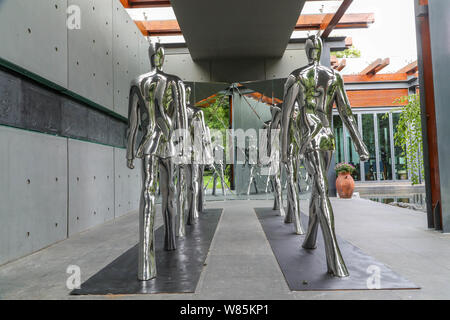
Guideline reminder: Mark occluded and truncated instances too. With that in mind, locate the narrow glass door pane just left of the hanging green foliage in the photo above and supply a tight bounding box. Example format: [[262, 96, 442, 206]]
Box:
[[377, 113, 392, 180]]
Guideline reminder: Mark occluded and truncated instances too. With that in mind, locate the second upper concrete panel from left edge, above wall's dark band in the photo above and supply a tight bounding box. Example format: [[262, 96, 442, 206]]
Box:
[[68, 0, 114, 110]]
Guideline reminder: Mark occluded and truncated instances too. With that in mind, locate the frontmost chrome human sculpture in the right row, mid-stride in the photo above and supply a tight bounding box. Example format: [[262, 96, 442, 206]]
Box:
[[281, 36, 369, 277]]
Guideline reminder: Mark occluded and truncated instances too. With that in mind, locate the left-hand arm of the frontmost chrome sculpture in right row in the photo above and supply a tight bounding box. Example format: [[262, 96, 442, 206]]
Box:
[[280, 75, 299, 163]]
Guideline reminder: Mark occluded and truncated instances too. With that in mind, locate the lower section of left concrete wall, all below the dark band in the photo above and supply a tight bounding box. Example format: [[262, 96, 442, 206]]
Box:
[[0, 126, 141, 264]]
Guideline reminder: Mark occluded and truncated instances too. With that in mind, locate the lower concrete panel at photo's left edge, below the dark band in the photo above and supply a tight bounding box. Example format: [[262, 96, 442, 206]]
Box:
[[0, 127, 67, 264]]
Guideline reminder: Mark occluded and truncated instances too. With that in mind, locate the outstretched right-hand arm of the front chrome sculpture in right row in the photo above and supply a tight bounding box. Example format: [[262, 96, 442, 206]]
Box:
[[335, 72, 369, 161]]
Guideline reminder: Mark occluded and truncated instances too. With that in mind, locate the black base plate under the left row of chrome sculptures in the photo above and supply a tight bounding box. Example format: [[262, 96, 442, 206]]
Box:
[[71, 209, 222, 295]]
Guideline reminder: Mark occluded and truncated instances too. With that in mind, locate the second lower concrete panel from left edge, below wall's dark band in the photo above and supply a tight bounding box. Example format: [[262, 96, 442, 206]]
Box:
[[69, 139, 114, 236]]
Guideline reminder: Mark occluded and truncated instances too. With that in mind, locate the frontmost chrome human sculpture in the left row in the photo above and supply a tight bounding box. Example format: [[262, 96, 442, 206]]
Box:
[[127, 43, 187, 280]]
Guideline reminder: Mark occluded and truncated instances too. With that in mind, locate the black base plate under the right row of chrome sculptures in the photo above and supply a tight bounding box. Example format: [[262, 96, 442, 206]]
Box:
[[255, 208, 419, 291]]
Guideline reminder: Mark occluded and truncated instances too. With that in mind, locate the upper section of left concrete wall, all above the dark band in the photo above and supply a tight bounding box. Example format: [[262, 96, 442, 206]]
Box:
[[0, 0, 148, 117]]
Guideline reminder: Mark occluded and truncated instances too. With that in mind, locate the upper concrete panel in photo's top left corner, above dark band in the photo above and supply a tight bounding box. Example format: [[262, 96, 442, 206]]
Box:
[[0, 0, 67, 87]]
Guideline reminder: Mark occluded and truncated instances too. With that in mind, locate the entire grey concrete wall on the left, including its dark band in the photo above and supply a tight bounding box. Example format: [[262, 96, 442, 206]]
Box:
[[0, 0, 145, 264]]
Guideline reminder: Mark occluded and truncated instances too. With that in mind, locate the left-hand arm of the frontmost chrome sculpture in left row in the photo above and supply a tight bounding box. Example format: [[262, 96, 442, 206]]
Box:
[[127, 87, 140, 169]]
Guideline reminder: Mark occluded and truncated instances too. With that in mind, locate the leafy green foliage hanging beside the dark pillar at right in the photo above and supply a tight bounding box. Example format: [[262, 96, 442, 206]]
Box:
[[385, 94, 423, 184]]
